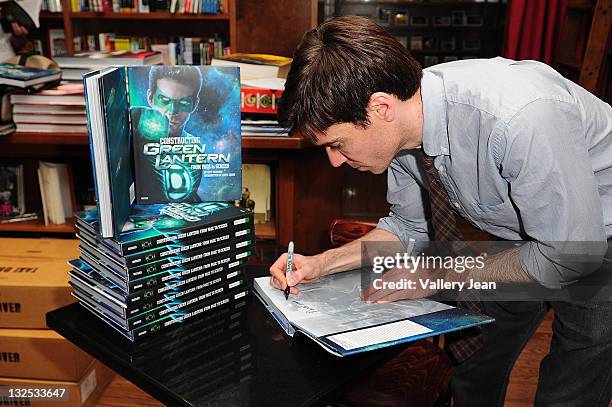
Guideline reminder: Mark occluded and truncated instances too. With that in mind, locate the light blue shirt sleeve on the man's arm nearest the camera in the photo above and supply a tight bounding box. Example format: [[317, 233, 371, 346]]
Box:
[[502, 100, 607, 288]]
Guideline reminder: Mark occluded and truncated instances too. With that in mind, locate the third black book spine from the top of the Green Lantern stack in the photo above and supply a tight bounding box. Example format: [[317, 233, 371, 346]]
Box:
[[124, 237, 255, 279]]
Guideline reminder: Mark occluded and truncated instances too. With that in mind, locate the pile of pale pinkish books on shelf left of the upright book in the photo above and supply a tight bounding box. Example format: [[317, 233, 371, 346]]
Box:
[[11, 84, 87, 133]]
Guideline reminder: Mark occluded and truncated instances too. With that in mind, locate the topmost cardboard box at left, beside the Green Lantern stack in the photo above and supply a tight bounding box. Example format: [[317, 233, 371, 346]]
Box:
[[0, 238, 79, 328]]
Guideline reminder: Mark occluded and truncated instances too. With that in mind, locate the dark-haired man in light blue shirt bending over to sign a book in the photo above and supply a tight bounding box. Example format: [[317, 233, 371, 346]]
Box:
[[270, 17, 612, 407]]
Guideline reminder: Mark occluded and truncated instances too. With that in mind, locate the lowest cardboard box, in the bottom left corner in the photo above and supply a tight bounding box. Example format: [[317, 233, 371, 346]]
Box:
[[0, 360, 115, 407]]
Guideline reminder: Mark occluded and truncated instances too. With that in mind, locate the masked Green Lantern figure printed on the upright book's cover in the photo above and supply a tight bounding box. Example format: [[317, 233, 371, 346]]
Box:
[[130, 66, 202, 203]]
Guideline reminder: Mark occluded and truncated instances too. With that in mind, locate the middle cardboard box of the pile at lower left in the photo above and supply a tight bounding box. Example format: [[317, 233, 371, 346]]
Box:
[[0, 329, 93, 382]]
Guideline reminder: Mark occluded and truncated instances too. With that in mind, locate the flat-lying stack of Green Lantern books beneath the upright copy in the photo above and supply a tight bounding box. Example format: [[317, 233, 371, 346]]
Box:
[[70, 202, 255, 341]]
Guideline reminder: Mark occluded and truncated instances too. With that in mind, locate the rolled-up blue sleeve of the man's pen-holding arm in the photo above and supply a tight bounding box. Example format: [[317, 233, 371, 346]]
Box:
[[377, 151, 429, 247]]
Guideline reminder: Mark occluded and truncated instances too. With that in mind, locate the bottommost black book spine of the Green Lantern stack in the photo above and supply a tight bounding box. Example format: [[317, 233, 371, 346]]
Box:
[[132, 288, 249, 340]]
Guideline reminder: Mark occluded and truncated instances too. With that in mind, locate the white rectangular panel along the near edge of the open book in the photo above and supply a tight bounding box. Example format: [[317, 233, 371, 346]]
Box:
[[327, 321, 431, 350]]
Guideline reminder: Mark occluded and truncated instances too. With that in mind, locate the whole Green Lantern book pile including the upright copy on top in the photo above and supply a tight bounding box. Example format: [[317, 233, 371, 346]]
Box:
[[75, 66, 247, 341]]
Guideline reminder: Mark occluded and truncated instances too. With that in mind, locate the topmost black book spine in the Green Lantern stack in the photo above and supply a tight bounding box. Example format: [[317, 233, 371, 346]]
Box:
[[120, 212, 254, 256]]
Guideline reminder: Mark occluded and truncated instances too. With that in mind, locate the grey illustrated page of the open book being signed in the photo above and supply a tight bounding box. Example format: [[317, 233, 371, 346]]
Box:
[[255, 270, 453, 337]]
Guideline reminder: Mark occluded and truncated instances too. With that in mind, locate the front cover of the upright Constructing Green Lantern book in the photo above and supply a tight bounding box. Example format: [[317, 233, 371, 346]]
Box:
[[128, 66, 242, 204]]
